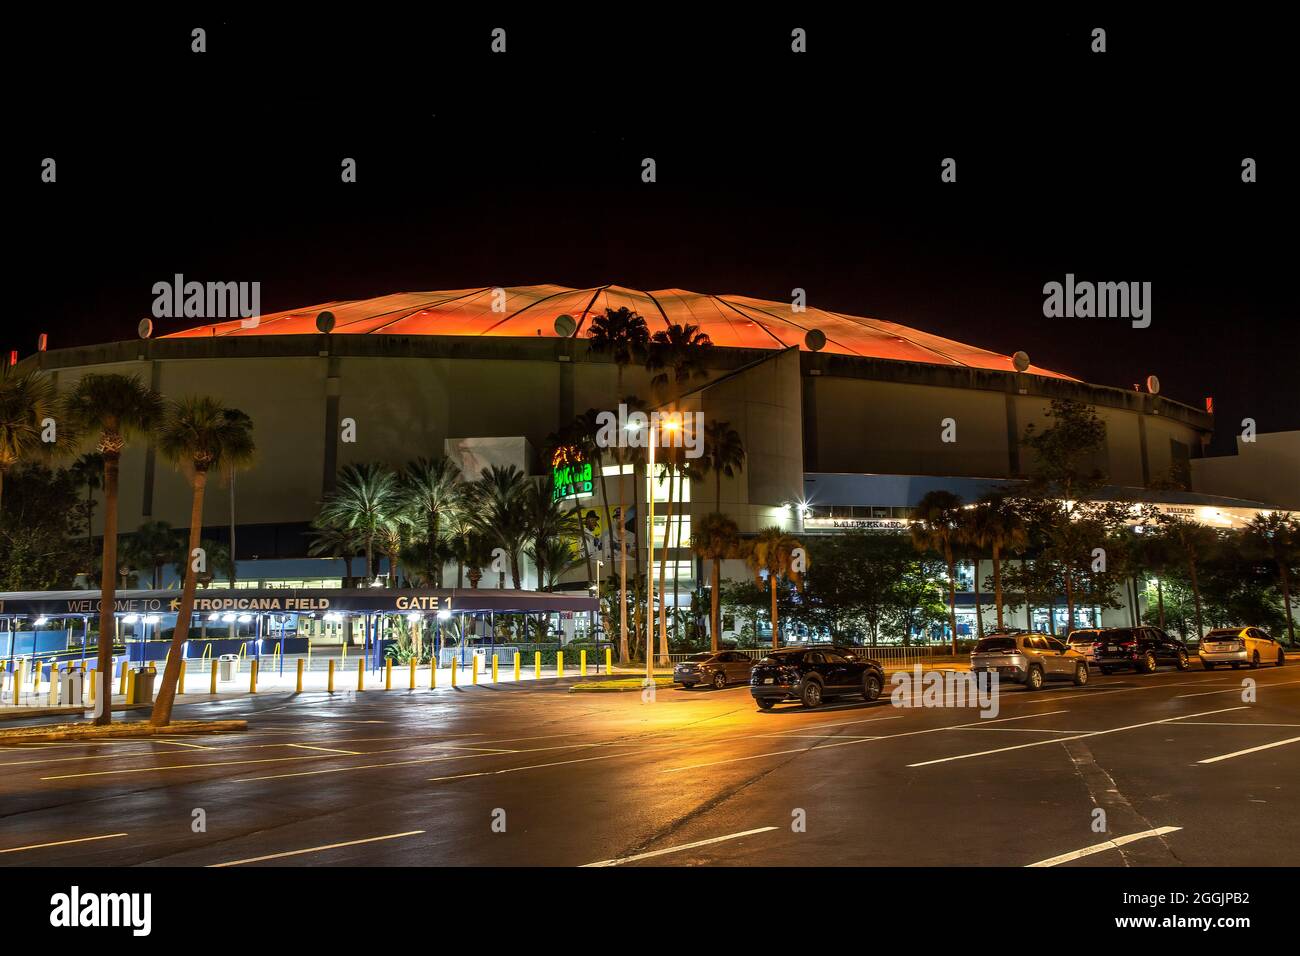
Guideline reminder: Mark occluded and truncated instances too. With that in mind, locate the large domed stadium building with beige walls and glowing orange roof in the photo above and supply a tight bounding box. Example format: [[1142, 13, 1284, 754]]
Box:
[[22, 285, 1266, 639]]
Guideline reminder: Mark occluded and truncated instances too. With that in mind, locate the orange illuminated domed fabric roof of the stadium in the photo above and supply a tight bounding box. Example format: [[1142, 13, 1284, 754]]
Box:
[[164, 285, 1073, 380]]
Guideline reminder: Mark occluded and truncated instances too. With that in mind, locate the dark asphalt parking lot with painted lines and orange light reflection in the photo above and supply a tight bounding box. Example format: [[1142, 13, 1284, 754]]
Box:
[[0, 666, 1300, 866]]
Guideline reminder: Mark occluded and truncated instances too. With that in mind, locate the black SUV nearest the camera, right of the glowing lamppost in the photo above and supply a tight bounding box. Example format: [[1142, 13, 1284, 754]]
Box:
[[749, 644, 885, 710]]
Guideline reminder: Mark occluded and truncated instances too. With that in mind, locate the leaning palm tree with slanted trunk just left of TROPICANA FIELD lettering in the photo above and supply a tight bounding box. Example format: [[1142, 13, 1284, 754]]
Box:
[[150, 395, 255, 727]]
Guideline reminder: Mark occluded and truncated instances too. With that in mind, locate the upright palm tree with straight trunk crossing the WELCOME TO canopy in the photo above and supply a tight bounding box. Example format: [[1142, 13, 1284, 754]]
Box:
[[64, 373, 163, 724]]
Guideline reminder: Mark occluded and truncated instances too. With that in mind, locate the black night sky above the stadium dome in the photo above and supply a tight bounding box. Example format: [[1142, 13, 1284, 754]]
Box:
[[0, 8, 1300, 453]]
